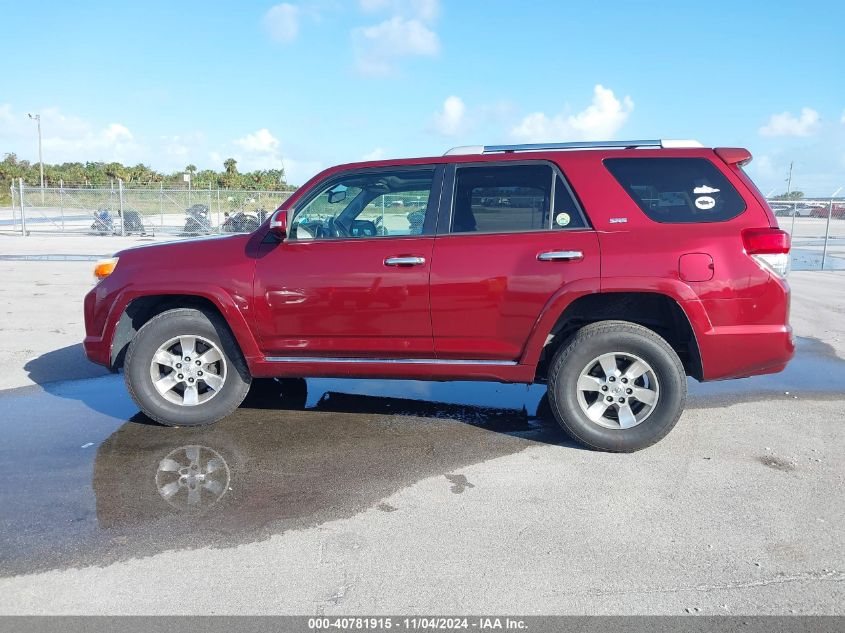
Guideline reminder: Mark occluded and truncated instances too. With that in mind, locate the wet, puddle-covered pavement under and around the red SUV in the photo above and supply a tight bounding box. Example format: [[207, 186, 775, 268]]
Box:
[[0, 339, 845, 577]]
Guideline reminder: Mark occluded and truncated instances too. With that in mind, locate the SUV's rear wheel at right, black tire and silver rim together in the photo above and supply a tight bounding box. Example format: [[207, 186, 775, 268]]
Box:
[[549, 321, 686, 452]]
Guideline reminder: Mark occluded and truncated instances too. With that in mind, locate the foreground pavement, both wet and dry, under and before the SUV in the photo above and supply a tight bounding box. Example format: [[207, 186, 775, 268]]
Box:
[[0, 339, 845, 614]]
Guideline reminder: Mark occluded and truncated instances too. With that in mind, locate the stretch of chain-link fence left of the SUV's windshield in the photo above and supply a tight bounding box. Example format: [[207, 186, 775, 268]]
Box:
[[0, 181, 291, 237]]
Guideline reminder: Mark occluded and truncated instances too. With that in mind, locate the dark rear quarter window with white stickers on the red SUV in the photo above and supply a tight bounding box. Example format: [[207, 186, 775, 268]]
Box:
[[604, 158, 745, 223]]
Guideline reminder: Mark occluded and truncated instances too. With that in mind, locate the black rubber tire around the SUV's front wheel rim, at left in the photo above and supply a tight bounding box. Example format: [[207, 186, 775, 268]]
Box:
[[124, 308, 252, 426]]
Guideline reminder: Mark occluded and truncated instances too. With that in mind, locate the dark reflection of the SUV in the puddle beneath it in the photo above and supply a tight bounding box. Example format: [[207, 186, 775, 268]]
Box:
[[93, 380, 566, 553]]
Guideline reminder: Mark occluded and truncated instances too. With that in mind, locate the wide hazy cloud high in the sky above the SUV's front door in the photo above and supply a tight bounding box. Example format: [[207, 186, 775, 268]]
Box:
[[352, 15, 440, 75]]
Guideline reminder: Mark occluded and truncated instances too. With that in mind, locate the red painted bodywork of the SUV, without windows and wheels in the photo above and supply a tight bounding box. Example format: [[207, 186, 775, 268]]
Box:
[[85, 148, 794, 382]]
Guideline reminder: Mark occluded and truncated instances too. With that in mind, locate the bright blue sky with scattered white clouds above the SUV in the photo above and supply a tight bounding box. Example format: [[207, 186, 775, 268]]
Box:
[[0, 0, 845, 196]]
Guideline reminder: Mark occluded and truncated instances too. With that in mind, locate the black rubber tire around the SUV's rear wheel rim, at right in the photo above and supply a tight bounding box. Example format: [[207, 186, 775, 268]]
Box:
[[548, 321, 687, 453]]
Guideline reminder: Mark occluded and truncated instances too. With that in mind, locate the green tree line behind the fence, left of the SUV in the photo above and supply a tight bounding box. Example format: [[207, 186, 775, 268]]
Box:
[[0, 154, 296, 201]]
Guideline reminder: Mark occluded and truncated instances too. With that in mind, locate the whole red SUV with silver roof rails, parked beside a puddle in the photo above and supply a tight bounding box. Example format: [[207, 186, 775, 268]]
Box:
[[85, 141, 794, 451]]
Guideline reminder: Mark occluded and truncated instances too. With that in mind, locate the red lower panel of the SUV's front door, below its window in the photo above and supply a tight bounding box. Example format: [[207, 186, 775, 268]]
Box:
[[254, 237, 434, 358]]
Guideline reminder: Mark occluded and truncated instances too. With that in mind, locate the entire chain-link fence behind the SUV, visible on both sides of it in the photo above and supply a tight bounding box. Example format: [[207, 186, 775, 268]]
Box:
[[0, 181, 845, 270]]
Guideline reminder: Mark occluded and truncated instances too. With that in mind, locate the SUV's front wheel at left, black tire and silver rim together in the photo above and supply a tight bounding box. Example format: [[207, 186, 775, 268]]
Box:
[[124, 308, 251, 426]]
